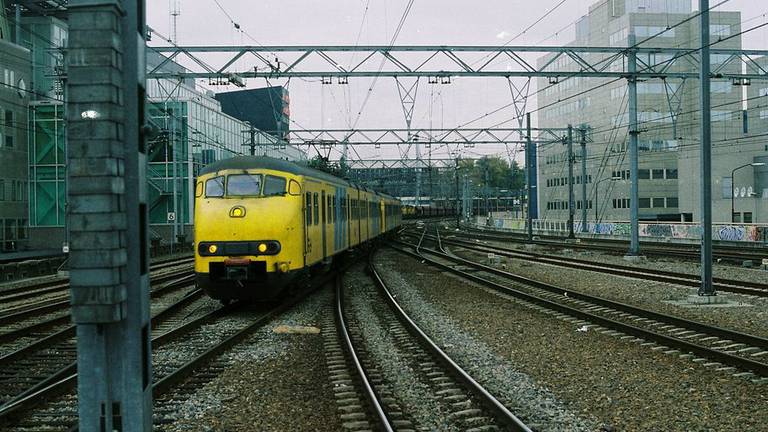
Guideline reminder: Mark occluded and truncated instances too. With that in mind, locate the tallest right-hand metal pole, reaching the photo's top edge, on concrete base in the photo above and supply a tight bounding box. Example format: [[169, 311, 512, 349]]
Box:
[[699, 0, 717, 296]]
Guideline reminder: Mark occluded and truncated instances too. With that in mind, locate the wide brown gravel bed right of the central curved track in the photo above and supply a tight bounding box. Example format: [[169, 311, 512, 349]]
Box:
[[378, 246, 768, 431]]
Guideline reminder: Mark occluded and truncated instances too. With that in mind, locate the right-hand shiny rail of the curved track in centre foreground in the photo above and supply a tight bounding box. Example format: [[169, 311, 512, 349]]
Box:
[[368, 253, 531, 432]]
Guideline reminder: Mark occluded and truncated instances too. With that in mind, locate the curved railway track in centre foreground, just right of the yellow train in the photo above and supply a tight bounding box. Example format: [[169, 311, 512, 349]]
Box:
[[334, 255, 531, 431]]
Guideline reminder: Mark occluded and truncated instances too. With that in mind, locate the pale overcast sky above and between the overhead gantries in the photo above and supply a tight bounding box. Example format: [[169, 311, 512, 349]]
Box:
[[147, 0, 768, 162]]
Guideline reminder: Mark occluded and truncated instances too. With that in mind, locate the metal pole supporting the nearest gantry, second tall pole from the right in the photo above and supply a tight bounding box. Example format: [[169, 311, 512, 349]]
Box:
[[628, 33, 640, 256]]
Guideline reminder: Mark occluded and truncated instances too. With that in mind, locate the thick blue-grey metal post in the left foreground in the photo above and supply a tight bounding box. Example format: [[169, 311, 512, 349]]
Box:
[[66, 0, 152, 432]]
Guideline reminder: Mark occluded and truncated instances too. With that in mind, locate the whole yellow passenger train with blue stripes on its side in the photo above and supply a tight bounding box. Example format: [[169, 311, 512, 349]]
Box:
[[195, 156, 402, 303]]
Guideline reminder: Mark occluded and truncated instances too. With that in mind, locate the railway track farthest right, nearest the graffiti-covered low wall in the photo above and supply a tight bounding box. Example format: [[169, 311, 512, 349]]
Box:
[[454, 226, 768, 264]]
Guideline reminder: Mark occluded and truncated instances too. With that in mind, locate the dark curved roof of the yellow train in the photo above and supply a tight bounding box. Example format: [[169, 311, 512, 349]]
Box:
[[200, 156, 397, 200]]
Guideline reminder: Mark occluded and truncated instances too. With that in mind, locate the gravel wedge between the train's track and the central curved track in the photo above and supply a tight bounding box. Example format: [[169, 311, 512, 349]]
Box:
[[155, 289, 341, 431]]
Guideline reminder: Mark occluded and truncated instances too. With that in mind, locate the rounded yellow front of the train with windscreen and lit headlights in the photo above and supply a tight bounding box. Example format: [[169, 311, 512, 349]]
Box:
[[195, 169, 303, 303]]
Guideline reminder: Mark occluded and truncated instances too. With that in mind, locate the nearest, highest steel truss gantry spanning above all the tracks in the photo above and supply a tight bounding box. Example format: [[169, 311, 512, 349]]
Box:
[[148, 45, 768, 80]]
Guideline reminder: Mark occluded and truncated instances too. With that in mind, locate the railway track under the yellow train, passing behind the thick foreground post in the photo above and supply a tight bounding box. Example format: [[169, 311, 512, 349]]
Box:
[[0, 262, 344, 431]]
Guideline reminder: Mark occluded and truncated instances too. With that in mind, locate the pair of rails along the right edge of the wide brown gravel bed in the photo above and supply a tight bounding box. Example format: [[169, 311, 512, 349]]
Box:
[[393, 240, 768, 376]]
